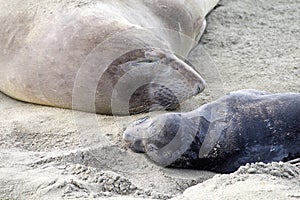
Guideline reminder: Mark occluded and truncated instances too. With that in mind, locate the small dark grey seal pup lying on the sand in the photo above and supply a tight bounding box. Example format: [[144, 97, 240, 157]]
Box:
[[124, 90, 300, 173]]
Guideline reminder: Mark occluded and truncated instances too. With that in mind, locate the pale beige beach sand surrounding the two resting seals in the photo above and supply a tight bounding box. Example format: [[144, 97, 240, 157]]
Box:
[[0, 0, 300, 199]]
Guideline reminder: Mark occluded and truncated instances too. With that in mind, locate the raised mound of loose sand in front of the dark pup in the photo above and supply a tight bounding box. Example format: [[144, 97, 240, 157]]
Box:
[[174, 162, 300, 200]]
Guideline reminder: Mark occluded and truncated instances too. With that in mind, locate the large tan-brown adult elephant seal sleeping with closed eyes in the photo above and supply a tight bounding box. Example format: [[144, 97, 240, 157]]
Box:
[[0, 0, 218, 114]]
